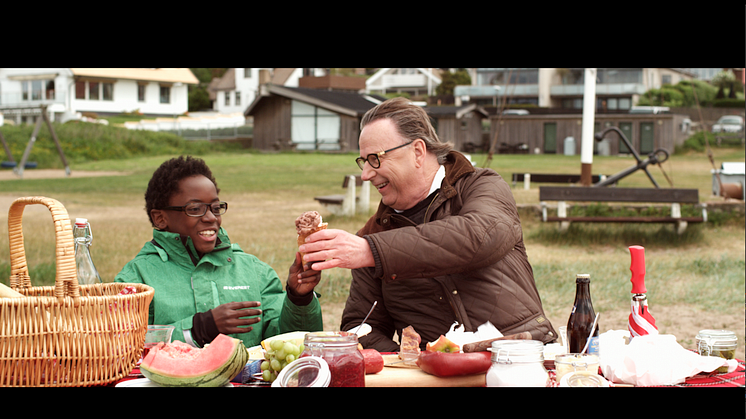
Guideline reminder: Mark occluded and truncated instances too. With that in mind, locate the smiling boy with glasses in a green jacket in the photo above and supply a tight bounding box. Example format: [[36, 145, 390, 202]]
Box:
[[115, 156, 323, 348]]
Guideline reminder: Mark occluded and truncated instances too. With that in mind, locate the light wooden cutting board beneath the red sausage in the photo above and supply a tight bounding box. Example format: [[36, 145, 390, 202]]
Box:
[[365, 354, 486, 387]]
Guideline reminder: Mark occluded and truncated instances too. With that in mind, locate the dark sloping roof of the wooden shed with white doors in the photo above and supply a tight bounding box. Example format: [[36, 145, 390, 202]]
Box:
[[244, 84, 384, 117]]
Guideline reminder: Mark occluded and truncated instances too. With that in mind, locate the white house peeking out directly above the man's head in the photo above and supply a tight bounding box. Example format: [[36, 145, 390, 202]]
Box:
[[365, 68, 442, 96]]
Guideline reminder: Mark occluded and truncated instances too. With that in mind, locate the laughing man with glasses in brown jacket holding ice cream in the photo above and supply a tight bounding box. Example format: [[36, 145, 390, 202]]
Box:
[[299, 98, 558, 352]]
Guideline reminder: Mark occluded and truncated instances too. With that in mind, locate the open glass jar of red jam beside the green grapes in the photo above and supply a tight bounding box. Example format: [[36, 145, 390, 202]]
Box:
[[301, 332, 365, 387]]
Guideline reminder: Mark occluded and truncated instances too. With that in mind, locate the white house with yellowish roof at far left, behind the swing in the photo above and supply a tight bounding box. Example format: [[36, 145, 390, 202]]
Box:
[[0, 68, 199, 124]]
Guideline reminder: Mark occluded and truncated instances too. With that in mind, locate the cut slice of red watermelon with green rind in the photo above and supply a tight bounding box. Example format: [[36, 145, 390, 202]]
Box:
[[140, 334, 249, 387]]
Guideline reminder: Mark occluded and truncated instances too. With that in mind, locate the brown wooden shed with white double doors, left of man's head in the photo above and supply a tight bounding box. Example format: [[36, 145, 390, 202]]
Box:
[[244, 84, 380, 151]]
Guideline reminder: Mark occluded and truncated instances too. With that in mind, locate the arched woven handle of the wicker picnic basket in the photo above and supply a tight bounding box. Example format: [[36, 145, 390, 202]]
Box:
[[8, 196, 80, 306]]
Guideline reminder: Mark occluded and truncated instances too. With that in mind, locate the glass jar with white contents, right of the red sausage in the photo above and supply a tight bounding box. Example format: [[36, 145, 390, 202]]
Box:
[[486, 340, 549, 387]]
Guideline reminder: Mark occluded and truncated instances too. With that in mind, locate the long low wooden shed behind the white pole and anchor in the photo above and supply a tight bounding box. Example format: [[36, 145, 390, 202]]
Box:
[[490, 113, 689, 155]]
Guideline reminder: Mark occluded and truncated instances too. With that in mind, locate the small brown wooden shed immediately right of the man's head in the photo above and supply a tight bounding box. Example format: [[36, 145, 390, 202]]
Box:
[[424, 104, 489, 153]]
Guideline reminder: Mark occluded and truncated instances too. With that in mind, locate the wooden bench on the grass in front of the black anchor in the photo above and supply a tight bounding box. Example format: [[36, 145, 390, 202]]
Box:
[[539, 186, 707, 234]]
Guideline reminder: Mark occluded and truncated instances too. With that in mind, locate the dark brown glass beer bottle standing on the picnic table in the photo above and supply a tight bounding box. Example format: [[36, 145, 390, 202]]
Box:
[[567, 274, 600, 355]]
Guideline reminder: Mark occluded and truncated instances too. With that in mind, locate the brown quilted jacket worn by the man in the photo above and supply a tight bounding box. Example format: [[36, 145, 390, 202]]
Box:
[[340, 152, 557, 352]]
